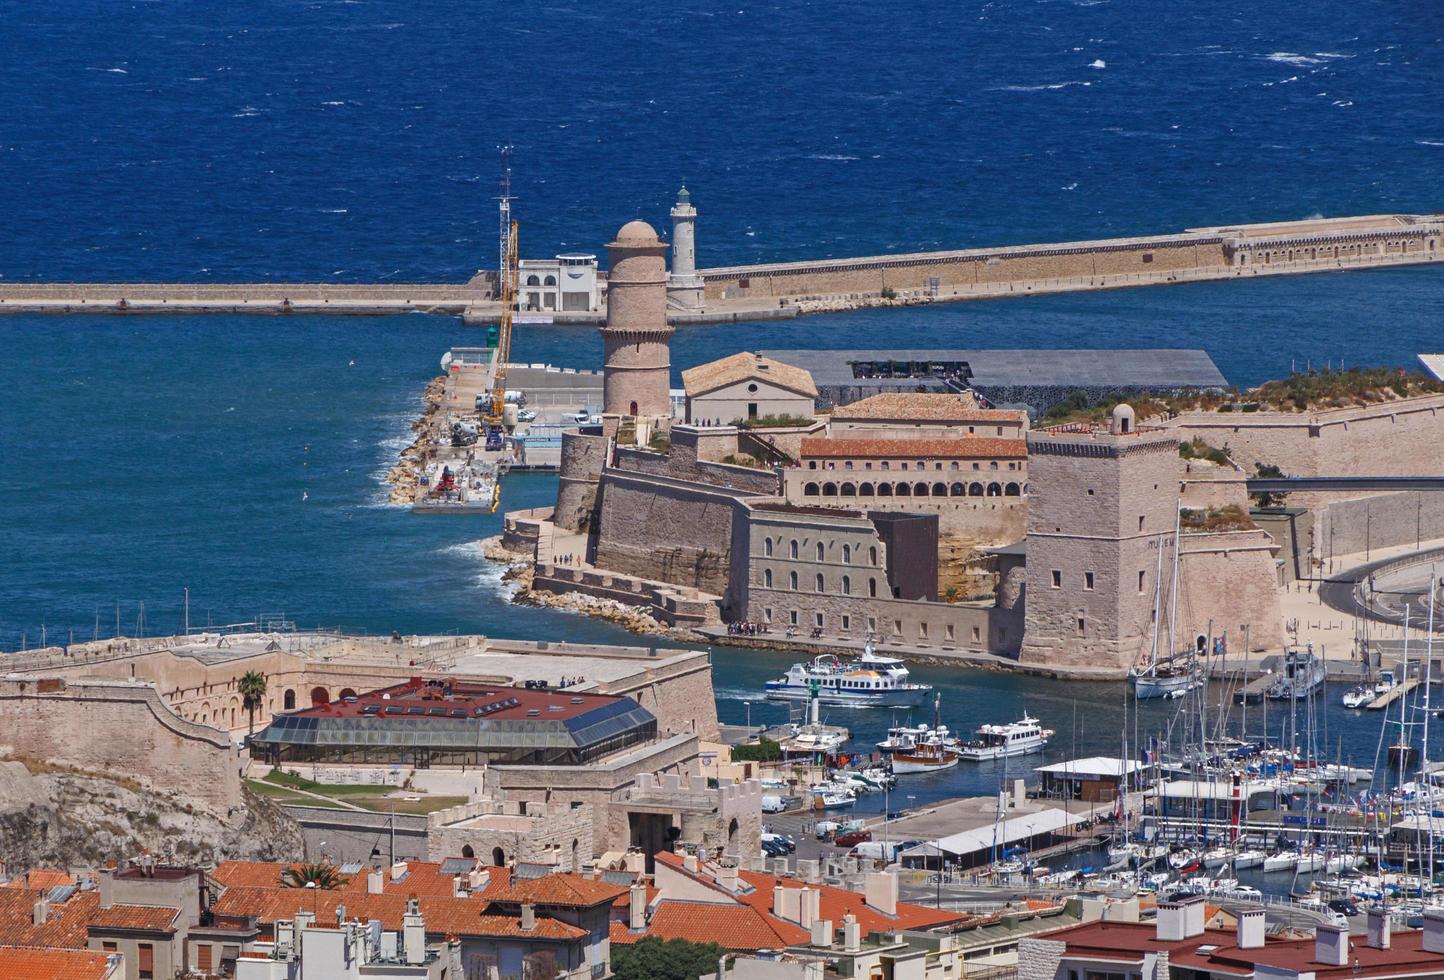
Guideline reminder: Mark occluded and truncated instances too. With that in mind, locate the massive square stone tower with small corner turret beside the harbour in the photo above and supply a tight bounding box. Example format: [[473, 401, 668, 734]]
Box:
[[1021, 406, 1183, 668]]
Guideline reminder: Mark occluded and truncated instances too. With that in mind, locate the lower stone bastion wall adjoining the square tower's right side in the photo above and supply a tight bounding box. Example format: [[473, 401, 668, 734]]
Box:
[[1178, 530, 1284, 652]]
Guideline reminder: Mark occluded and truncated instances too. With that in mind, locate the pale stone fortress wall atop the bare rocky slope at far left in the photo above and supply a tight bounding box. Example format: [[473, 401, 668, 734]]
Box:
[[0, 674, 241, 813]]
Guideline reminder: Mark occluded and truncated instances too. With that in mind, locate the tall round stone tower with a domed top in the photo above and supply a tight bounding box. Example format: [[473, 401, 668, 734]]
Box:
[[602, 221, 671, 419]]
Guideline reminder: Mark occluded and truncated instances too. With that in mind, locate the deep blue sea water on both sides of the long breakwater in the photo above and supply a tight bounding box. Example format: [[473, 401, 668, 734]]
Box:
[[0, 0, 1444, 779]]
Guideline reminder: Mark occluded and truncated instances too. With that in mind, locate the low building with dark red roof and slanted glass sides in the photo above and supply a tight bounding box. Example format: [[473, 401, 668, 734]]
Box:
[[250, 678, 657, 769]]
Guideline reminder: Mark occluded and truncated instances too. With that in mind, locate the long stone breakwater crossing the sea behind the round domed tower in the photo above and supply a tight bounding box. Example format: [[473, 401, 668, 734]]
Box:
[[0, 209, 1444, 325]]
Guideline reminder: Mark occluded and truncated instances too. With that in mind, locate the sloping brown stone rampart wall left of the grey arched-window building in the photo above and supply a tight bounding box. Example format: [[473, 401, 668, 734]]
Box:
[[593, 471, 749, 595]]
